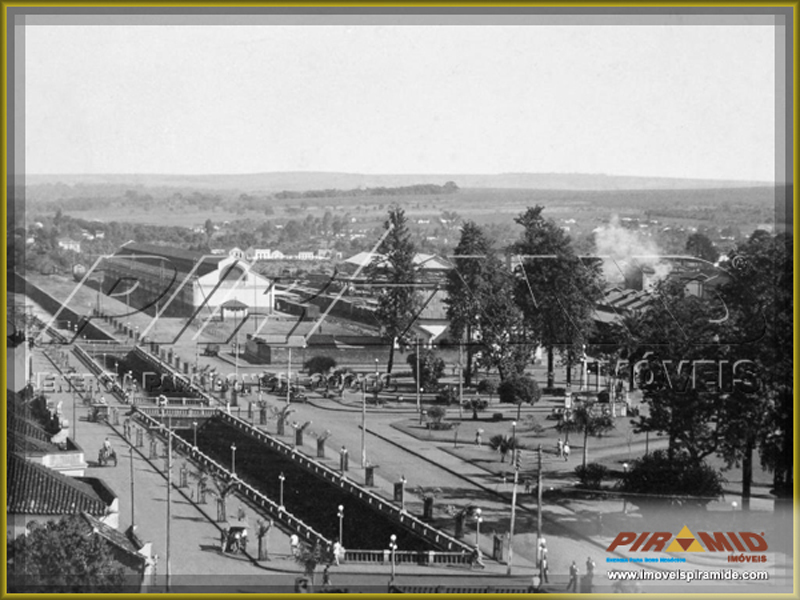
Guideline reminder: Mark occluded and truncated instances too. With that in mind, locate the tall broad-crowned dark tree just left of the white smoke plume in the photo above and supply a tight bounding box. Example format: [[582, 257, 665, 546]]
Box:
[[512, 206, 602, 388]]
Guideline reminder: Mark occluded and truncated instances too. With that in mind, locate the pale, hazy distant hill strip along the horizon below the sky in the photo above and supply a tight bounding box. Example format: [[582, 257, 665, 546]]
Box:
[[25, 171, 773, 193]]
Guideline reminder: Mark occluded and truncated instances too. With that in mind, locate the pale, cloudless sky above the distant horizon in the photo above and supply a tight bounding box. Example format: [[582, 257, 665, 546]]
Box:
[[24, 25, 776, 182]]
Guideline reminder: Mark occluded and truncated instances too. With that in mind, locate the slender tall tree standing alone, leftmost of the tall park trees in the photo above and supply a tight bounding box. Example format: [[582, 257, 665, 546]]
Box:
[[367, 207, 420, 373]]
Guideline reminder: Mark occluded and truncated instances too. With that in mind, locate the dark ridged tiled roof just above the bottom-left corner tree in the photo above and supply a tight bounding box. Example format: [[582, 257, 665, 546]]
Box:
[[7, 453, 108, 515]]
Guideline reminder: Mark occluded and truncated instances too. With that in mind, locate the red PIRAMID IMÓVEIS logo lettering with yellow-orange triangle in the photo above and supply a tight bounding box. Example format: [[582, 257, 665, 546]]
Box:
[[606, 525, 769, 562]]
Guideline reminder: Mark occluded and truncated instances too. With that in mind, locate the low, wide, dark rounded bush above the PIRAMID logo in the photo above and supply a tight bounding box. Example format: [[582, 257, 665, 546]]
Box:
[[621, 450, 723, 506]]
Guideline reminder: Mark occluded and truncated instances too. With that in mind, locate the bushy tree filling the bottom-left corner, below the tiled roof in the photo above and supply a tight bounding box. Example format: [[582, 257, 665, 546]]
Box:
[[7, 516, 125, 594]]
